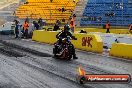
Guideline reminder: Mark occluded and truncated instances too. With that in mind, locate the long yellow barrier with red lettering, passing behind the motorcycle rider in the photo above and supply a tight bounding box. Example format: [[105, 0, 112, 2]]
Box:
[[32, 30, 103, 53]]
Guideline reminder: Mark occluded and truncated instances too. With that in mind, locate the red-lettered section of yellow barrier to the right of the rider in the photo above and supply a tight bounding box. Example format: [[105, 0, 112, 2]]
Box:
[[72, 34, 103, 53]]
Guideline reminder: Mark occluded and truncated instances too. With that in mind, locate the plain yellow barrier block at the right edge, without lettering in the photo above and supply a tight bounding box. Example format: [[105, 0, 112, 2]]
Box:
[[110, 43, 132, 59]]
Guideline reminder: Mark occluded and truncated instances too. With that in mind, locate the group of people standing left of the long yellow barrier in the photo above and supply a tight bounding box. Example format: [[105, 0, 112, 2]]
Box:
[[14, 17, 46, 39]]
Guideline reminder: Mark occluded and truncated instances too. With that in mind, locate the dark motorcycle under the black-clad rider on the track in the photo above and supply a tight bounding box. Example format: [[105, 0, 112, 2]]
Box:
[[53, 37, 77, 60]]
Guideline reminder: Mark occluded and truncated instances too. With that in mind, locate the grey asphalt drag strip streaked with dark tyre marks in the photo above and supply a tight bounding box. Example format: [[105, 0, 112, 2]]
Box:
[[0, 35, 132, 88]]
